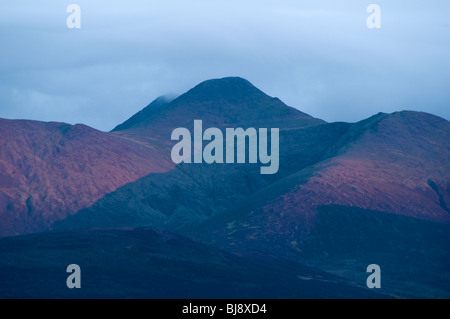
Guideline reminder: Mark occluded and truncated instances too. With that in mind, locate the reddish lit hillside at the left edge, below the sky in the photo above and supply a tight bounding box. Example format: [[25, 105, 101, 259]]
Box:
[[0, 119, 172, 236]]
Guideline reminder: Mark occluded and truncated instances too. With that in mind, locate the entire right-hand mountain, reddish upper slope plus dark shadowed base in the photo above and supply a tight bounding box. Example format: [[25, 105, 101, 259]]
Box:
[[192, 112, 450, 298]]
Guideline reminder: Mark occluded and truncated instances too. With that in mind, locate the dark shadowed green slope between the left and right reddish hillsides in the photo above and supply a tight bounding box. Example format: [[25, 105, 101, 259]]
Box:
[[53, 123, 349, 231]]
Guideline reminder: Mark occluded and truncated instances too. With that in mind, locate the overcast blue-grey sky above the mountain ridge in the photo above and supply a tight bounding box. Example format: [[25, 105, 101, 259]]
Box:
[[0, 0, 450, 131]]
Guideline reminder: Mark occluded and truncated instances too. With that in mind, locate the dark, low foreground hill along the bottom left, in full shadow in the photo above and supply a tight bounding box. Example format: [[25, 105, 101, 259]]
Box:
[[0, 228, 388, 299]]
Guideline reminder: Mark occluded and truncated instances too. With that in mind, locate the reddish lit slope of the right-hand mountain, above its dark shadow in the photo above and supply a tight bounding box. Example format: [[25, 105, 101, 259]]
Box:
[[211, 112, 450, 248]]
